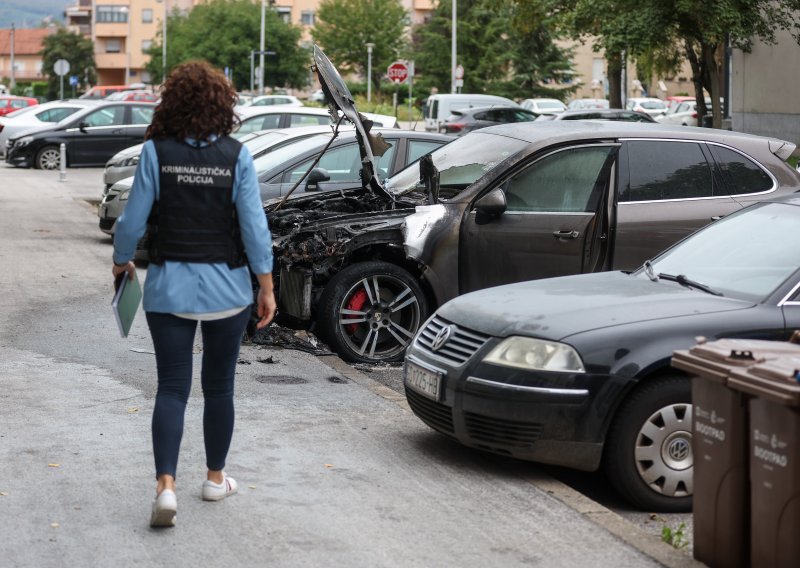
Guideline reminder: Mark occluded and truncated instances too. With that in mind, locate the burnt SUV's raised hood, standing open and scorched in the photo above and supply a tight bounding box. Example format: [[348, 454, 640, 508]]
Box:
[[314, 45, 394, 201]]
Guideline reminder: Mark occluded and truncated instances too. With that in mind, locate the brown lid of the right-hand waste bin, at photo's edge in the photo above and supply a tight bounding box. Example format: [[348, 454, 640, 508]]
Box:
[[728, 356, 800, 408]]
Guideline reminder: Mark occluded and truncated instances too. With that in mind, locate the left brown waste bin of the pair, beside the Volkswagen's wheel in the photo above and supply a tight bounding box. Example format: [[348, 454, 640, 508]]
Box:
[[672, 338, 800, 568]]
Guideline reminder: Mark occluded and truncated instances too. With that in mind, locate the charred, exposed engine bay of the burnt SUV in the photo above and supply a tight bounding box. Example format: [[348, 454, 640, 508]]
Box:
[[266, 188, 420, 275]]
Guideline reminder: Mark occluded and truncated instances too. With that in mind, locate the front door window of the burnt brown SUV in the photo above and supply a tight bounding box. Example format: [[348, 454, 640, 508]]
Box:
[[505, 146, 614, 213]]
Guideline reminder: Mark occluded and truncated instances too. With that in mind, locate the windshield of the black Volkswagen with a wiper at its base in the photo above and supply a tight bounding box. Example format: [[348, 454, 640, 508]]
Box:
[[648, 203, 800, 301]]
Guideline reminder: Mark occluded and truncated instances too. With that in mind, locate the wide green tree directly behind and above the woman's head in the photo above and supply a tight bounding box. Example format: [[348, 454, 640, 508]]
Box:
[[145, 0, 311, 89]]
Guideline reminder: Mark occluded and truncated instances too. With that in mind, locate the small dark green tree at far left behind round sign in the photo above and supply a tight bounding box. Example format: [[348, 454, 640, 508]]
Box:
[[42, 28, 97, 99]]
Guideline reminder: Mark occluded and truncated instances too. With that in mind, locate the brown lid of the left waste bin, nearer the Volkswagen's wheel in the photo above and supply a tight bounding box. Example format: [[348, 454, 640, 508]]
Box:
[[672, 336, 800, 383]]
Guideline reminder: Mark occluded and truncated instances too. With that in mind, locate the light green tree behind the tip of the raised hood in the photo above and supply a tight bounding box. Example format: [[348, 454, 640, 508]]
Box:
[[311, 0, 408, 96]]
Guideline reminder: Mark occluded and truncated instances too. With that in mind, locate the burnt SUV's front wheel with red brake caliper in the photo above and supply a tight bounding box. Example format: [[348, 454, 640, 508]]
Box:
[[317, 261, 428, 363]]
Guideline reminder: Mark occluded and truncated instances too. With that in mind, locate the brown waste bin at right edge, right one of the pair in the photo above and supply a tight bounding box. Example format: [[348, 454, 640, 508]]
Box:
[[729, 357, 800, 568]]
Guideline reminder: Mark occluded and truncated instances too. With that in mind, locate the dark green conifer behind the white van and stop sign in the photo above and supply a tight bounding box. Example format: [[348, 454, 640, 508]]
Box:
[[414, 0, 574, 98]]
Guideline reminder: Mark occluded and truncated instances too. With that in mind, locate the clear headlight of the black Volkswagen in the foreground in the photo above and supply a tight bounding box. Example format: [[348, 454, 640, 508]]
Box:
[[483, 336, 586, 373]]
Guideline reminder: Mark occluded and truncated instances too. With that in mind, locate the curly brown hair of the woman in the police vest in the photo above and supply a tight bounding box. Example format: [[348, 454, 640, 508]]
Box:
[[145, 61, 239, 140]]
